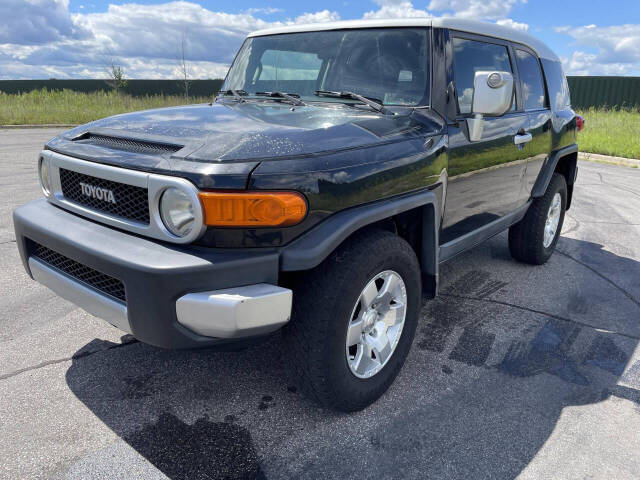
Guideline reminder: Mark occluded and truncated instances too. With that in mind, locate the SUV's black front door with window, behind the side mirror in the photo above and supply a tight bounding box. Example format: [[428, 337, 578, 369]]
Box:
[[440, 32, 528, 244]]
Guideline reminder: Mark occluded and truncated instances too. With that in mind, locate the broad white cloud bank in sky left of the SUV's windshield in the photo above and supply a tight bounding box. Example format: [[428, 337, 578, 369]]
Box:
[[0, 0, 340, 78]]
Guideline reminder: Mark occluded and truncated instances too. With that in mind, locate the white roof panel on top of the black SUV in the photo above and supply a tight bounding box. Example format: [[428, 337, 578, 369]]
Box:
[[249, 17, 558, 61]]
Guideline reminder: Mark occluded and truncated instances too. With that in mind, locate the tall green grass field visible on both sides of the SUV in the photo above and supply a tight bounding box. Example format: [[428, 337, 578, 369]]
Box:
[[0, 89, 640, 158]]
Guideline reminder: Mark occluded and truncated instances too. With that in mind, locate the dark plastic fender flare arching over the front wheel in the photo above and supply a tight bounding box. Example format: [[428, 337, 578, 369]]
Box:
[[280, 190, 440, 295]]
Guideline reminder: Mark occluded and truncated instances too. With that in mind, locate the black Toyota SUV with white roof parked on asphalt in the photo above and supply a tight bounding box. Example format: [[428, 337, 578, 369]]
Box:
[[14, 19, 577, 411]]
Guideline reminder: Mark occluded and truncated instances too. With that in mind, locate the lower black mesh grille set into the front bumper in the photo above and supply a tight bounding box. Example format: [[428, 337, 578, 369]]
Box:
[[31, 241, 127, 302]]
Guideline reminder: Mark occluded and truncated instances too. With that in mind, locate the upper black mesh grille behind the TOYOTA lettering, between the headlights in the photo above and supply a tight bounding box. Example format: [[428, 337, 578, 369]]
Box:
[[60, 168, 149, 225]]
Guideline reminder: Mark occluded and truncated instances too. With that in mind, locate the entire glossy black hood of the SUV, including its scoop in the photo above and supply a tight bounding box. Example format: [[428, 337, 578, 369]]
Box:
[[47, 101, 443, 188]]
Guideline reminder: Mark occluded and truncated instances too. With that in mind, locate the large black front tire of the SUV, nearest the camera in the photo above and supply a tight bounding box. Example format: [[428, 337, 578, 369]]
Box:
[[283, 230, 422, 412]]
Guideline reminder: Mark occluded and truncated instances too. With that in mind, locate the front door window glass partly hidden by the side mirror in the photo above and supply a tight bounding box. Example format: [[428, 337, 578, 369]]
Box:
[[453, 37, 516, 114]]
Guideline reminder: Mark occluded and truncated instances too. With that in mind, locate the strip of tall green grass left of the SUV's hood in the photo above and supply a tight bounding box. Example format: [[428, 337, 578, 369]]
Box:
[[0, 89, 213, 125]]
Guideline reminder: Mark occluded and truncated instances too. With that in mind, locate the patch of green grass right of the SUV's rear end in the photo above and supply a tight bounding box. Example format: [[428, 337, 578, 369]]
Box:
[[578, 108, 640, 158]]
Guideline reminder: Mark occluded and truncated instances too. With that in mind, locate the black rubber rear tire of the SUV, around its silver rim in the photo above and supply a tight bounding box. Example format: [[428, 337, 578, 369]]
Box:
[[509, 173, 567, 265]]
